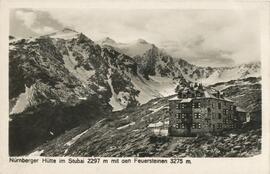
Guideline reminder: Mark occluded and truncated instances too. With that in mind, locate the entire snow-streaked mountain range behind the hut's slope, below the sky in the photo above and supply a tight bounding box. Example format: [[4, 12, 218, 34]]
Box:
[[9, 28, 261, 154]]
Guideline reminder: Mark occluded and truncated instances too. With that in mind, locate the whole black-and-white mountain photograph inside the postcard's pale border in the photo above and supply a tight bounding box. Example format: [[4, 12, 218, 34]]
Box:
[[8, 8, 262, 158]]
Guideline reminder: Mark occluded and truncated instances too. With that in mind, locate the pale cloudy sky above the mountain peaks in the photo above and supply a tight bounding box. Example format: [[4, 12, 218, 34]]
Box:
[[10, 9, 260, 66]]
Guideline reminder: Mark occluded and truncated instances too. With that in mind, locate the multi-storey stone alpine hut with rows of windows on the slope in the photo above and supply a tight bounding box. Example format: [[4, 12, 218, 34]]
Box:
[[168, 83, 239, 136]]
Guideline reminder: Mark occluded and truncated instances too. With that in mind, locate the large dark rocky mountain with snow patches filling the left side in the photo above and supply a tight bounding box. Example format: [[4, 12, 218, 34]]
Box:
[[9, 29, 143, 154]]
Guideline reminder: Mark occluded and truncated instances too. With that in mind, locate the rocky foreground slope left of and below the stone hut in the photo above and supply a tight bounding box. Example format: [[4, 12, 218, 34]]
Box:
[[28, 95, 261, 157]]
